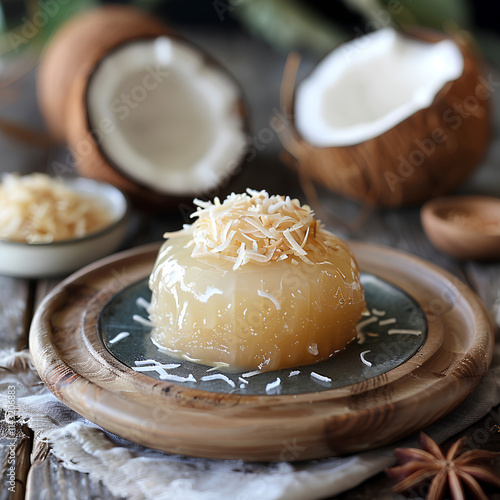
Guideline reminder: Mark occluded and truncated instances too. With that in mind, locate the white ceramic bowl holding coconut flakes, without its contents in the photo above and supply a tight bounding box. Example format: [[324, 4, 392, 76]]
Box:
[[0, 178, 129, 278]]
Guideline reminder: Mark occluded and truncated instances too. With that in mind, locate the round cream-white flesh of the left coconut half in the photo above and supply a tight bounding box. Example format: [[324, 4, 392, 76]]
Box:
[[86, 37, 246, 195]]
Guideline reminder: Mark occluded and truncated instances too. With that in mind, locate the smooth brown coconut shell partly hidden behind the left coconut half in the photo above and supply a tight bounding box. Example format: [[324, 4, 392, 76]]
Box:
[[37, 5, 171, 140]]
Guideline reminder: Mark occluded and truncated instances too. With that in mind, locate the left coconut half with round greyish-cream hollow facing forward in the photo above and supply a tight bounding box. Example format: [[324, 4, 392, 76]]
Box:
[[39, 8, 248, 208]]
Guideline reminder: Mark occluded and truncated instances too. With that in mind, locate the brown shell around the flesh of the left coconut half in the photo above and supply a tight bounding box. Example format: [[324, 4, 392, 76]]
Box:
[[66, 33, 250, 211]]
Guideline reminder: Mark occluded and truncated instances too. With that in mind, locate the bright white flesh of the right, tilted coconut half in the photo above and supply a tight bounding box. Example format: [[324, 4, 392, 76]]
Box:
[[294, 28, 464, 147]]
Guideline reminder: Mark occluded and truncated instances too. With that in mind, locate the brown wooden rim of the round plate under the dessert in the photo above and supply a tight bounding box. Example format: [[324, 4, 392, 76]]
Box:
[[30, 242, 493, 461]]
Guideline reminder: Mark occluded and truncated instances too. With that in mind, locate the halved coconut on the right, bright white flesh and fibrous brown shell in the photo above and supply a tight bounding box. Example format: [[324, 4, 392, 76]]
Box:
[[280, 28, 491, 206]]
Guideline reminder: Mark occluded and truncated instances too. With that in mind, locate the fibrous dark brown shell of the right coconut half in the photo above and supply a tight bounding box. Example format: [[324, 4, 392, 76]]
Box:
[[277, 29, 492, 207]]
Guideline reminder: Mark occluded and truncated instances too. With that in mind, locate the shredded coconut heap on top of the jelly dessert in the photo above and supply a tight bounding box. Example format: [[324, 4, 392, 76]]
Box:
[[164, 189, 329, 270]]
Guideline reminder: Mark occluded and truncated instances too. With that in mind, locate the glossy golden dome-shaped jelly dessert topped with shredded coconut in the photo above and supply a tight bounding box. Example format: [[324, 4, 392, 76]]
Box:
[[149, 190, 365, 371]]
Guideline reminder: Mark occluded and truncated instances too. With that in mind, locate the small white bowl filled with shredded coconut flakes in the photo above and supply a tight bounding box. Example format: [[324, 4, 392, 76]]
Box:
[[0, 174, 128, 278]]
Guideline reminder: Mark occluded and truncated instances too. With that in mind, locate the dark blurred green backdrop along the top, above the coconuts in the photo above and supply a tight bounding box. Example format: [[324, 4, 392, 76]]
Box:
[[0, 0, 500, 60]]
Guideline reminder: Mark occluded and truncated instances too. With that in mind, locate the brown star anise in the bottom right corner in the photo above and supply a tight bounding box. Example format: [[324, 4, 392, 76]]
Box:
[[386, 432, 500, 500]]
